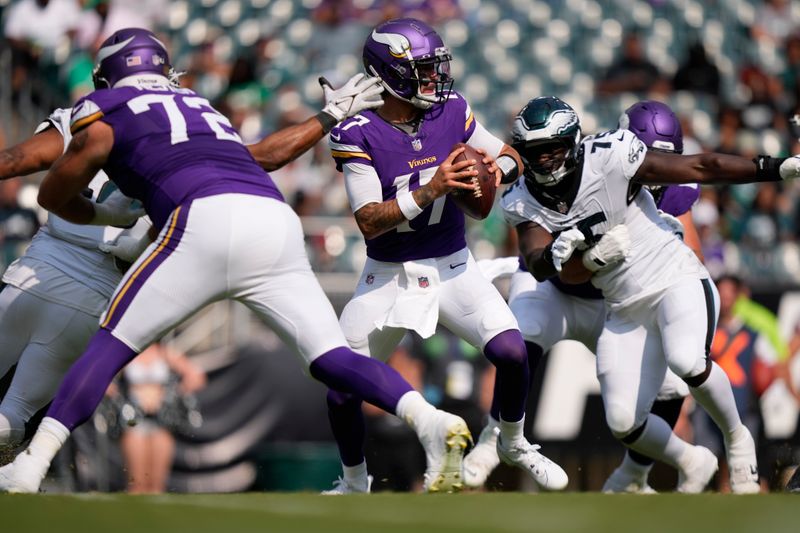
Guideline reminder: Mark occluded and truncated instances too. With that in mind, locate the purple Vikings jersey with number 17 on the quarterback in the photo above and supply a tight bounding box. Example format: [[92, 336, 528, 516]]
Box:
[[330, 92, 475, 263]]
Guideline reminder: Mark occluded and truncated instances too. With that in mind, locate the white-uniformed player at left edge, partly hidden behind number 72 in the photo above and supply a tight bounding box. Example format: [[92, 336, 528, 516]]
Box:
[[0, 109, 150, 447]]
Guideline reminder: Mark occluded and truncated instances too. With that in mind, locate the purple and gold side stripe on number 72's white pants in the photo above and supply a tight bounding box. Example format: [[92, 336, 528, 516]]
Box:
[[100, 205, 189, 330]]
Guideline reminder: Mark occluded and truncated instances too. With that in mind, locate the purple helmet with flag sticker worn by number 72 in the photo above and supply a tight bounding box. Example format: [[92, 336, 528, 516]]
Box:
[[92, 28, 175, 89]]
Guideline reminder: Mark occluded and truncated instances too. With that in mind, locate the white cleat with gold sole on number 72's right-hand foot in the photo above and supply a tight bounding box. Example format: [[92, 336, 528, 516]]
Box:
[[417, 409, 472, 492]]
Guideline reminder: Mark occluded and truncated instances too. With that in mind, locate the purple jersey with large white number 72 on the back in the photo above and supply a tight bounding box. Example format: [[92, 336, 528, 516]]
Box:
[[70, 86, 283, 228]]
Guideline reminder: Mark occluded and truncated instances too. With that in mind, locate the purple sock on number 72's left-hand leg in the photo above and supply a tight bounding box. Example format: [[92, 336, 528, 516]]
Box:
[[47, 329, 137, 431]]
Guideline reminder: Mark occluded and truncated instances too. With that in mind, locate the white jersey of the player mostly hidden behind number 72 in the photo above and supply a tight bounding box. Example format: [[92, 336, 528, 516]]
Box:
[[3, 109, 149, 316]]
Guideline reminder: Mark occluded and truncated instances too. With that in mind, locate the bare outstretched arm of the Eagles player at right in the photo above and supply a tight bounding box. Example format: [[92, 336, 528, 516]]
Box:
[[633, 151, 784, 185]]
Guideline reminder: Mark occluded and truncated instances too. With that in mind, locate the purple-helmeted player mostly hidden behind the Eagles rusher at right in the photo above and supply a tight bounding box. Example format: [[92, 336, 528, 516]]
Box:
[[464, 101, 701, 493]]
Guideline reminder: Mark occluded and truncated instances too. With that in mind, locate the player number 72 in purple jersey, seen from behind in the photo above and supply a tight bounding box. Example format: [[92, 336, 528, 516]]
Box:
[[0, 28, 468, 492]]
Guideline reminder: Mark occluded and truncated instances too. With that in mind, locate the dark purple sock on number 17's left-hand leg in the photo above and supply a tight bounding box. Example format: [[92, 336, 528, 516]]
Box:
[[328, 389, 366, 466]]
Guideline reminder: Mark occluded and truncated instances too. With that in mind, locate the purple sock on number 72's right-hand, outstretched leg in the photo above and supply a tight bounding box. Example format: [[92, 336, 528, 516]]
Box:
[[308, 346, 414, 414]]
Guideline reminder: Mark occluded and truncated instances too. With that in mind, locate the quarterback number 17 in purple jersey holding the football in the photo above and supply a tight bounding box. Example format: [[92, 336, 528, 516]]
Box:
[[328, 19, 567, 493]]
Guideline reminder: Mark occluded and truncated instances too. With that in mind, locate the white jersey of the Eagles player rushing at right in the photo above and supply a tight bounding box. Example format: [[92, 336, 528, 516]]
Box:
[[500, 130, 709, 309]]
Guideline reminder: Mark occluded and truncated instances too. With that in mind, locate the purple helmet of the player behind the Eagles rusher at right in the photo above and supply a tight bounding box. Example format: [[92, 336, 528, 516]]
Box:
[[619, 100, 683, 154]]
